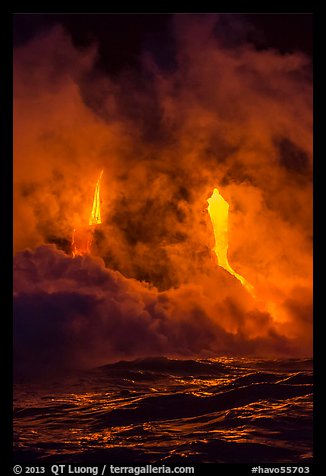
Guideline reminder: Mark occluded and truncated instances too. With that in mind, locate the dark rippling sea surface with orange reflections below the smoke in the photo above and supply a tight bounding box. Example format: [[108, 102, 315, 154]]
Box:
[[14, 358, 312, 464]]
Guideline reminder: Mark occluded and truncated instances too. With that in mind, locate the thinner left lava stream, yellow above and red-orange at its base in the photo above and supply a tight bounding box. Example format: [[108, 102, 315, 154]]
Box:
[[71, 170, 103, 257]]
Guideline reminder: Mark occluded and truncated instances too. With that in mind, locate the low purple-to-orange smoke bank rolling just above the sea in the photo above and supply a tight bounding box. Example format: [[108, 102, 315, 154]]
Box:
[[14, 245, 304, 376]]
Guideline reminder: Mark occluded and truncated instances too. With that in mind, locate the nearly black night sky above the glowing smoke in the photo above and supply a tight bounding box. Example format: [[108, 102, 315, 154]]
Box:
[[13, 13, 313, 75]]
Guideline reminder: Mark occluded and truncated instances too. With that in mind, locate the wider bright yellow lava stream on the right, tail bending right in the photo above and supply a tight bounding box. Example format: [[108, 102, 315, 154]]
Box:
[[207, 188, 254, 295]]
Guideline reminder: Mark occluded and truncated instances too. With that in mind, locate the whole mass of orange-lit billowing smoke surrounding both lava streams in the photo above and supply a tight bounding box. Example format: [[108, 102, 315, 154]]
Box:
[[14, 15, 312, 376]]
